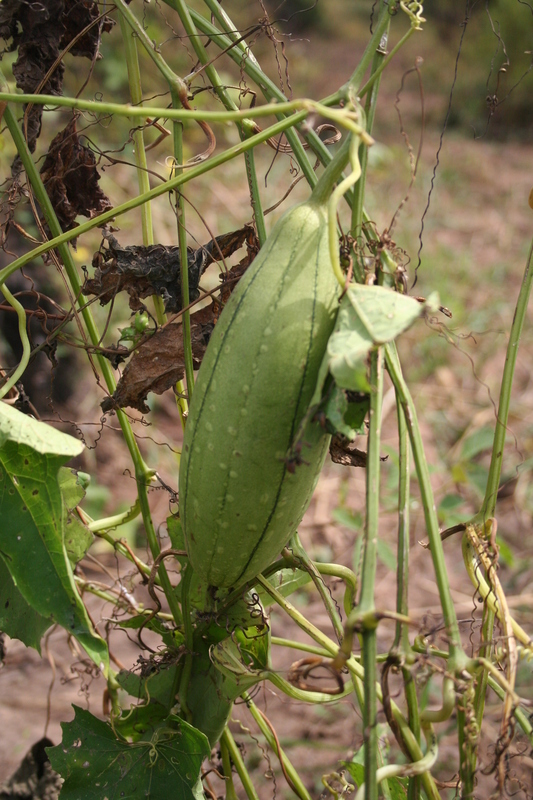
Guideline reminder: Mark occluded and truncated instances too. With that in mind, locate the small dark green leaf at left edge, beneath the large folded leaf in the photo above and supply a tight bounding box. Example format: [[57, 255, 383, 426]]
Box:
[[0, 558, 53, 653]]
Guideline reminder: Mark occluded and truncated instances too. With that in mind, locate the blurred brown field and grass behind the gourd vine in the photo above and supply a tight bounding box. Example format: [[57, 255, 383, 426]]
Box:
[[0, 0, 533, 796]]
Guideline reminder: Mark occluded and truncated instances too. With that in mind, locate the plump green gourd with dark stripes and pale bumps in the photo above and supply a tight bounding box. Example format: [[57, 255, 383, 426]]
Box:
[[180, 161, 339, 588]]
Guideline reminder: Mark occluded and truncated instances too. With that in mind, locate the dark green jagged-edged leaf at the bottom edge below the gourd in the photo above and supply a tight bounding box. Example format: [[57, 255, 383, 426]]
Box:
[[47, 706, 210, 800]]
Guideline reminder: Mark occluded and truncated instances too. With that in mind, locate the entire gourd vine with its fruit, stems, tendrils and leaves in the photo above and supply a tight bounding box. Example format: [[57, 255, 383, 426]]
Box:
[[0, 0, 533, 800]]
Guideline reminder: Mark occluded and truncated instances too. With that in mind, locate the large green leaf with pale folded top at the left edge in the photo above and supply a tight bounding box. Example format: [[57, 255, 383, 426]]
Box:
[[0, 403, 109, 673]]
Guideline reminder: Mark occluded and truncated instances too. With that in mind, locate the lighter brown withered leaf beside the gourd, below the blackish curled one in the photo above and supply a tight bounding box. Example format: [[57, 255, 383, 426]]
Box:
[[101, 304, 215, 414]]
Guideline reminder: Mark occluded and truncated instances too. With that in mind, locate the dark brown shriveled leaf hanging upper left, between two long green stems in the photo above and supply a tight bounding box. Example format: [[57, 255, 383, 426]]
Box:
[[41, 116, 112, 231]]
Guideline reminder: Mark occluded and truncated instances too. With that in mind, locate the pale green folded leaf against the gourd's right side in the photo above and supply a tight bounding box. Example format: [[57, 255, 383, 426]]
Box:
[[327, 284, 435, 392]]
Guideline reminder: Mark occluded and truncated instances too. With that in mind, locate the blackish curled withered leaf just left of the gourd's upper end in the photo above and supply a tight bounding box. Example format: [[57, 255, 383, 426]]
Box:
[[83, 226, 253, 314]]
